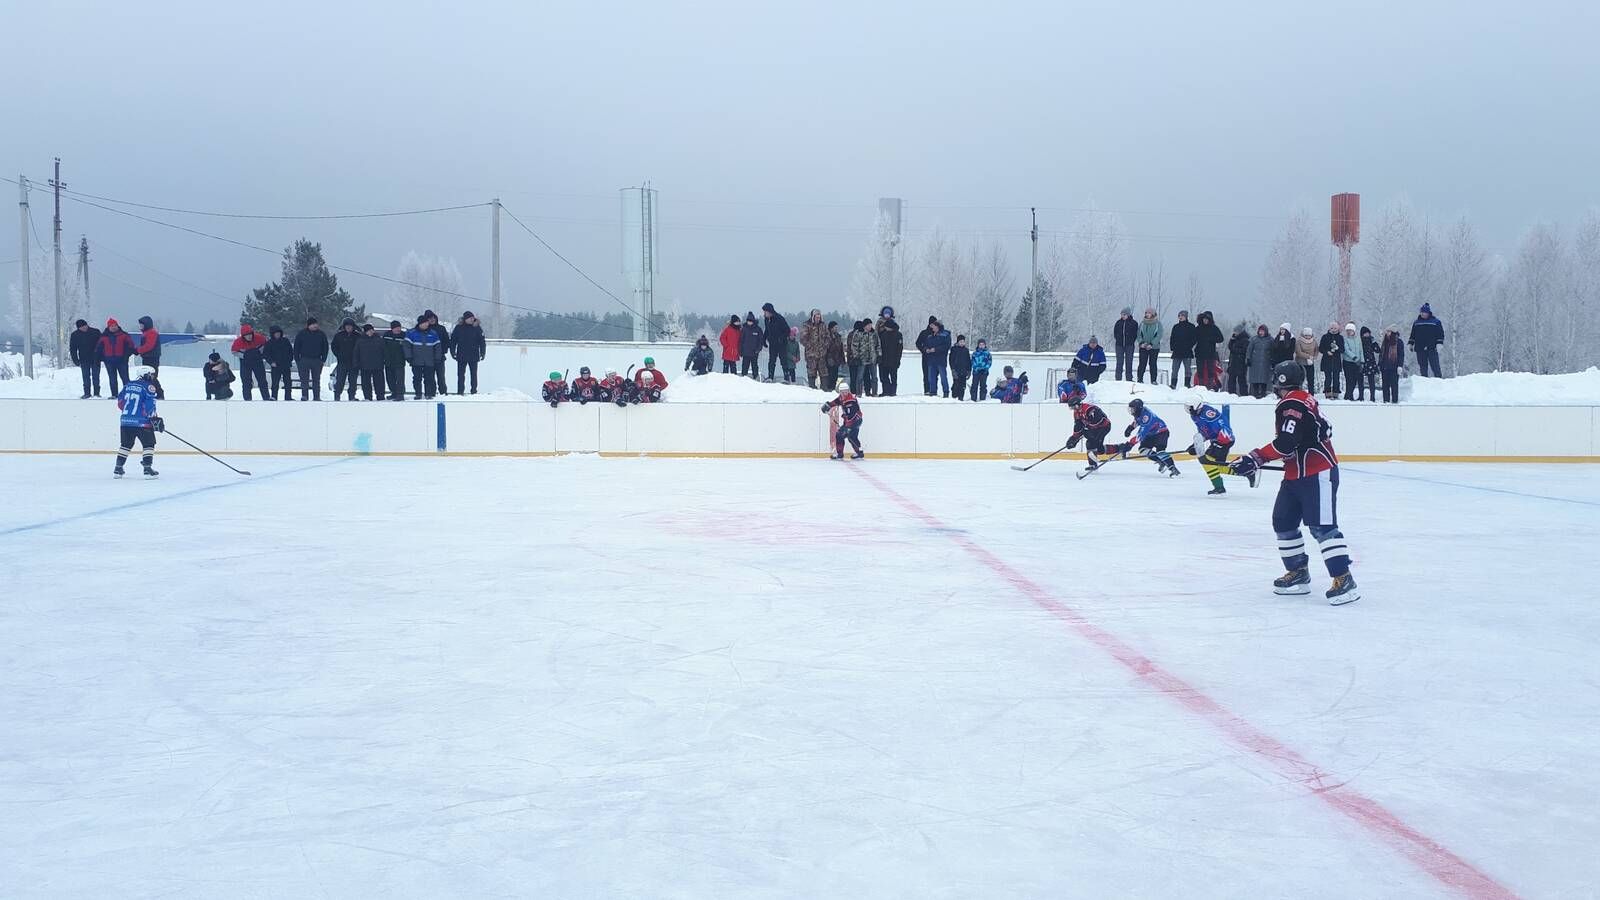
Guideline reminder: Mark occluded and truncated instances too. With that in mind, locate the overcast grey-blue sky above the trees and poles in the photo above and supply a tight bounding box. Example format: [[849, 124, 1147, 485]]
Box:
[[0, 0, 1600, 329]]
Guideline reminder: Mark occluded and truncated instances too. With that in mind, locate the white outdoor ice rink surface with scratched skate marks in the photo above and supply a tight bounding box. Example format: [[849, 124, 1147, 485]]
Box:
[[0, 454, 1600, 898]]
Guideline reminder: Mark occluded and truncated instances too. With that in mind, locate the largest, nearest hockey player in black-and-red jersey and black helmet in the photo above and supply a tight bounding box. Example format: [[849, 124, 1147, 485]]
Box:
[[1230, 362, 1362, 605]]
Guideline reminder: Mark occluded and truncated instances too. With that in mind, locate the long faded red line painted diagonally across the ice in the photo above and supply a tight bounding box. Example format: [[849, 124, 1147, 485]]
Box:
[[851, 466, 1517, 898]]
